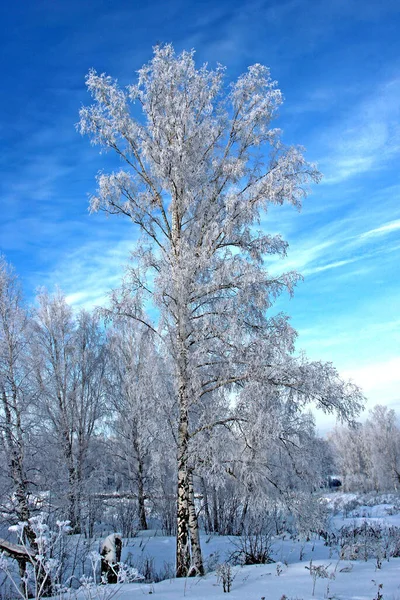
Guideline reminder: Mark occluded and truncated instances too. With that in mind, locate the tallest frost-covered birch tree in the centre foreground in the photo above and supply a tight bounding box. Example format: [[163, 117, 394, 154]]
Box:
[[80, 45, 361, 576]]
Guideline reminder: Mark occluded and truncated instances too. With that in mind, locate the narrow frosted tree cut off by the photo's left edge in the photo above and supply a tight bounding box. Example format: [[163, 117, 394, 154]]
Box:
[[0, 256, 45, 589]]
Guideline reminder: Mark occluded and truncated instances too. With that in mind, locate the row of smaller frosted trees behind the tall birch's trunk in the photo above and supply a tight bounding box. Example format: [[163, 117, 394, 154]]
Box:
[[0, 258, 336, 536]]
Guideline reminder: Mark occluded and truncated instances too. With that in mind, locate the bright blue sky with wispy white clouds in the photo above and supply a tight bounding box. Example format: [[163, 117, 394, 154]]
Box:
[[0, 0, 400, 428]]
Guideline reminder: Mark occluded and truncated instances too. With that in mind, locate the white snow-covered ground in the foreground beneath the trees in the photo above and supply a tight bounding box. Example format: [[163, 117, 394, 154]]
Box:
[[4, 493, 400, 600]]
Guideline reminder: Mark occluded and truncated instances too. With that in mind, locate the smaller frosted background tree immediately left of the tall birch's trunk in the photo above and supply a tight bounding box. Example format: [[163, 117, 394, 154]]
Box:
[[107, 319, 171, 529]]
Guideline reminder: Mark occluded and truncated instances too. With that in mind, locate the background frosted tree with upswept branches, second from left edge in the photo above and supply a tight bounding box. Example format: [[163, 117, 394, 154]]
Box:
[[32, 291, 106, 532]]
